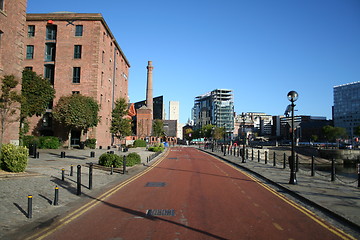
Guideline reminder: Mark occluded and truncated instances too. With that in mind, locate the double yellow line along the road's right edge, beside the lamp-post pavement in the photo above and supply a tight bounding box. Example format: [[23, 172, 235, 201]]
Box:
[[214, 155, 356, 240]]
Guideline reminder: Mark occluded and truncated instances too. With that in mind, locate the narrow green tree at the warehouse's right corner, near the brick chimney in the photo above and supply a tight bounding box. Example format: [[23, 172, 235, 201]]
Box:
[[110, 98, 131, 140]]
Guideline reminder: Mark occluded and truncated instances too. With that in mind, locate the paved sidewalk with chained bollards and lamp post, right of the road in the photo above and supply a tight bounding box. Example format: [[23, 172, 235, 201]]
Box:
[[202, 149, 360, 233]]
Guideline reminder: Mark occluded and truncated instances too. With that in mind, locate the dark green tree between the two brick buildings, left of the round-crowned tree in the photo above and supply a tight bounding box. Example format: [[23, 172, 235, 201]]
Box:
[[20, 69, 55, 145]]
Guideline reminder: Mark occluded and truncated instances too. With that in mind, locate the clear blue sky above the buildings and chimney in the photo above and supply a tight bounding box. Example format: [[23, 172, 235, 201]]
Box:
[[28, 0, 360, 123]]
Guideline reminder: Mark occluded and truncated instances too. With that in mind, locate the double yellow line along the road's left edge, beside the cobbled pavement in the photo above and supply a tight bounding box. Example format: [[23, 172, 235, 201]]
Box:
[[26, 151, 169, 240]]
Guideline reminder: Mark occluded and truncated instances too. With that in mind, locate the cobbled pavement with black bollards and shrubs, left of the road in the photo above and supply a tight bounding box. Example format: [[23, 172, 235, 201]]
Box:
[[0, 148, 160, 239]]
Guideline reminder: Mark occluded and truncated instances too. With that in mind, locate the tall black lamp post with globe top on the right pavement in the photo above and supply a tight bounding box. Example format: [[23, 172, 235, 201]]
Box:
[[287, 91, 299, 184]]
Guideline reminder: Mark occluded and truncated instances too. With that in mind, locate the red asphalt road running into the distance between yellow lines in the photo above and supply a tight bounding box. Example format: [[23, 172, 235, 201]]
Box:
[[35, 147, 351, 240]]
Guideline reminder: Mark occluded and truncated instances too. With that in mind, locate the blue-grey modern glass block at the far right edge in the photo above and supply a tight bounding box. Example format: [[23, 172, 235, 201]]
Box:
[[333, 82, 360, 138]]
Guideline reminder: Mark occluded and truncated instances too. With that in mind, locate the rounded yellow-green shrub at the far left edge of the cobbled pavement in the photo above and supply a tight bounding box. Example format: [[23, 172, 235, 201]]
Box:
[[0, 144, 29, 172]]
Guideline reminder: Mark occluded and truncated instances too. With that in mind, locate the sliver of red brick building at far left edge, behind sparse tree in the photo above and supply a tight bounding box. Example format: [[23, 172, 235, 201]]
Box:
[[0, 0, 27, 144]]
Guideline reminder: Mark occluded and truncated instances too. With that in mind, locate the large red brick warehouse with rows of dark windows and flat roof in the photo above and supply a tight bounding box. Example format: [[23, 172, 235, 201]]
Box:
[[23, 12, 130, 147]]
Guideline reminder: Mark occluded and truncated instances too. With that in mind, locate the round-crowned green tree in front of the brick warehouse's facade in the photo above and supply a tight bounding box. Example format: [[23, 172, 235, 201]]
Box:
[[53, 94, 99, 148]]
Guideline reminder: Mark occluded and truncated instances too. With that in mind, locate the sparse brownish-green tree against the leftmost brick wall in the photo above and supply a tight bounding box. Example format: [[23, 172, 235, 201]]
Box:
[[0, 75, 21, 152]]
